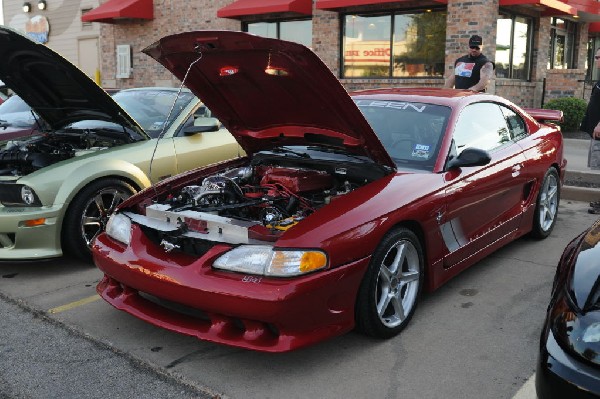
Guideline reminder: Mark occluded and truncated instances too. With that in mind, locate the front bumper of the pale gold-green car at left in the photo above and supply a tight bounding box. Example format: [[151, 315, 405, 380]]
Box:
[[0, 206, 62, 261]]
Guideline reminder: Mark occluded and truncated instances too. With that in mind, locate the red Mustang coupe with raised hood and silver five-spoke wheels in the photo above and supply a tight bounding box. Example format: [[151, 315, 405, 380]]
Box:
[[93, 31, 566, 352]]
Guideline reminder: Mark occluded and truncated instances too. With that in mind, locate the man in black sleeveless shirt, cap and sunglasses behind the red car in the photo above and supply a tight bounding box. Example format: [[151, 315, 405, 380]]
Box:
[[444, 35, 494, 91]]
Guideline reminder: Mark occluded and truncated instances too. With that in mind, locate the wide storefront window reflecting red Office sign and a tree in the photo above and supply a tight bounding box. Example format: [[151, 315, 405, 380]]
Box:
[[342, 11, 446, 78]]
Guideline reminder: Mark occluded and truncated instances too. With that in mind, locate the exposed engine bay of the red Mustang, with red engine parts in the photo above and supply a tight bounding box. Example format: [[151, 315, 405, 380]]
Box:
[[124, 148, 387, 255]]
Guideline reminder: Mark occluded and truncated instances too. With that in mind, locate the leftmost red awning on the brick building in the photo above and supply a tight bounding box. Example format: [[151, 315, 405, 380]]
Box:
[[81, 0, 154, 24]]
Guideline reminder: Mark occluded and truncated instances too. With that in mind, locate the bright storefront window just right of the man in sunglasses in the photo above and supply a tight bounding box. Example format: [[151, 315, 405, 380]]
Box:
[[496, 14, 532, 80]]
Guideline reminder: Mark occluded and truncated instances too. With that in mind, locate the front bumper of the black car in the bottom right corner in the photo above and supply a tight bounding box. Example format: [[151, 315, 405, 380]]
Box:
[[535, 328, 600, 399]]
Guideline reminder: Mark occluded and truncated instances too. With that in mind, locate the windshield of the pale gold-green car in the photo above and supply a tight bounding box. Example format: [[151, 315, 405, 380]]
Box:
[[113, 89, 195, 138]]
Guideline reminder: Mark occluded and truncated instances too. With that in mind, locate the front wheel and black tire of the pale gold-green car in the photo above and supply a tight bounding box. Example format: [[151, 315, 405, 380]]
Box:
[[61, 179, 136, 262]]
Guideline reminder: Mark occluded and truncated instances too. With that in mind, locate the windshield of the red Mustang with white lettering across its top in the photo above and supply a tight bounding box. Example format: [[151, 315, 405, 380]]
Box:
[[354, 100, 451, 171]]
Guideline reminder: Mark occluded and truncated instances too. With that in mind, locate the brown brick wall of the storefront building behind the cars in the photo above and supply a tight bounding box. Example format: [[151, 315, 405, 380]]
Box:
[[95, 0, 588, 107]]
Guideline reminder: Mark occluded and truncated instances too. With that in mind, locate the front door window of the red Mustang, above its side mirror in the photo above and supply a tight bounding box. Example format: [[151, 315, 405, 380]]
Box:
[[453, 103, 512, 154]]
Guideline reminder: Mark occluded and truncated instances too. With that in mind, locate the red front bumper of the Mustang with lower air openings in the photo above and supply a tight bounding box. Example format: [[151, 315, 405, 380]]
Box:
[[92, 226, 369, 352]]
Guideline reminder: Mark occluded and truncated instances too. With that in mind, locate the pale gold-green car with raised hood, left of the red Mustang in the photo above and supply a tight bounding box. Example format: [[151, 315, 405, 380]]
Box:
[[0, 27, 240, 260]]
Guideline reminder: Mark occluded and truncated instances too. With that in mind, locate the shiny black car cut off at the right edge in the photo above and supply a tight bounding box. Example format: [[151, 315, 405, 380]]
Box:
[[536, 220, 600, 399]]
